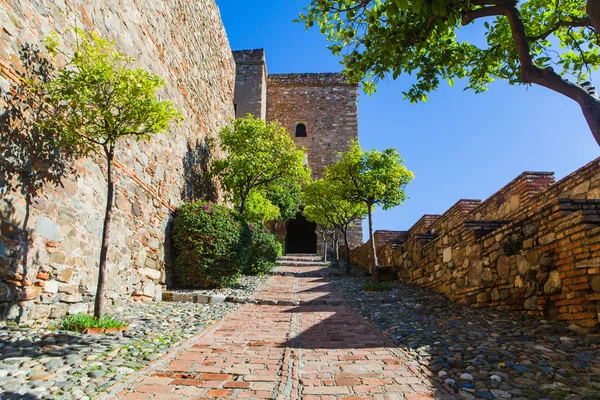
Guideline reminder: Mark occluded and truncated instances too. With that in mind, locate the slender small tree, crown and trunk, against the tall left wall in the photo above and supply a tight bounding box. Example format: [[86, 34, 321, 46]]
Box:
[[46, 28, 182, 318]]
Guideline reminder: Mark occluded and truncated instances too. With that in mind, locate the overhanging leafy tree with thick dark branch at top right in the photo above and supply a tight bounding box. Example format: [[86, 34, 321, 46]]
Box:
[[300, 0, 600, 144]]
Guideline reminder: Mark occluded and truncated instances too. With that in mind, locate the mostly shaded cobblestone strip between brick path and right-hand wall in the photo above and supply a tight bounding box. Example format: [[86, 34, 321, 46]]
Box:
[[333, 278, 600, 400]]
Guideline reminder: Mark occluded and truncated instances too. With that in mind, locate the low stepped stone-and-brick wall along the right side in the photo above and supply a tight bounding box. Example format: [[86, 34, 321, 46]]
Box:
[[351, 158, 600, 328]]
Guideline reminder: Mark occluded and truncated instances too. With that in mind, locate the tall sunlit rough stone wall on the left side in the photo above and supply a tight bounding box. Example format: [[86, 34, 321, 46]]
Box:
[[0, 0, 235, 319]]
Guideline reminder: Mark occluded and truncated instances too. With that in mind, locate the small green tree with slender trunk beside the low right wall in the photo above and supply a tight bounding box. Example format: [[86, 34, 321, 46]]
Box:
[[325, 141, 414, 280]]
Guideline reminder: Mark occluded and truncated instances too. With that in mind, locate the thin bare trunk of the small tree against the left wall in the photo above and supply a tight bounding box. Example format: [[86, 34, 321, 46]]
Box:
[[94, 145, 115, 318]]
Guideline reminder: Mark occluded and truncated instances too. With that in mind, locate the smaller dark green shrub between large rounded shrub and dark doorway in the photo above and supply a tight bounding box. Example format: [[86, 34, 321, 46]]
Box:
[[243, 223, 282, 275]]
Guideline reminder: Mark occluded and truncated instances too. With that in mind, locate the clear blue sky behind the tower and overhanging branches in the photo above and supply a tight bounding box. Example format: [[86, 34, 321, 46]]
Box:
[[217, 0, 600, 238]]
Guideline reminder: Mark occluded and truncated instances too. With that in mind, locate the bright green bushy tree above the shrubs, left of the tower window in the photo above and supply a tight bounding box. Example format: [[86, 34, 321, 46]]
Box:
[[211, 114, 310, 221]]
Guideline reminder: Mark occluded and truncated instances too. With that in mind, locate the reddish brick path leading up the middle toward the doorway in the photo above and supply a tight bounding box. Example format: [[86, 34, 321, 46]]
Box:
[[110, 256, 449, 400]]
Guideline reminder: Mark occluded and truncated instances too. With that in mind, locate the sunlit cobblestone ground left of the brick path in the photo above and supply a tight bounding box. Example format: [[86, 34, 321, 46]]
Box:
[[0, 303, 237, 399]]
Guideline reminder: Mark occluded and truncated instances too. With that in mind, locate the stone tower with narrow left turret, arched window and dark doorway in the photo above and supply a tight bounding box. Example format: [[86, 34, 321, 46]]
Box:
[[233, 49, 362, 255]]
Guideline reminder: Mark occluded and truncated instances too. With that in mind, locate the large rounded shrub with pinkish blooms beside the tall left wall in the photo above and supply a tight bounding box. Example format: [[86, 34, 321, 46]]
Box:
[[172, 201, 251, 289]]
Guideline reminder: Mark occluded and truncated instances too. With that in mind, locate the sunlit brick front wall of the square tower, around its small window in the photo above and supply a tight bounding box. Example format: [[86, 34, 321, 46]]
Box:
[[267, 73, 362, 254]]
